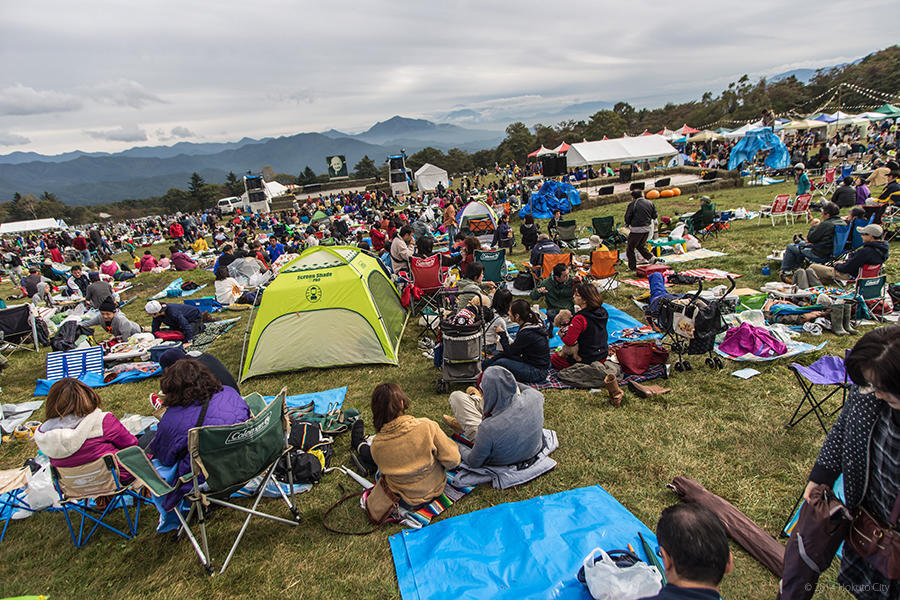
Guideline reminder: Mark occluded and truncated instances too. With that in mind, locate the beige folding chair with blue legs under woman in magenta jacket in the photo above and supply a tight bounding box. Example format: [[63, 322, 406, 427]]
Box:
[[50, 454, 150, 548]]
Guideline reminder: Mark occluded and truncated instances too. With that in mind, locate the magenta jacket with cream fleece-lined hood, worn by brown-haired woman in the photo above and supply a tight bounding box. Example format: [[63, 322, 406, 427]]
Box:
[[34, 408, 137, 467]]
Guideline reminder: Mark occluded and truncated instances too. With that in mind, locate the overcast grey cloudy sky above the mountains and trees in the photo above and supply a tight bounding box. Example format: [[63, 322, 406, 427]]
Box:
[[0, 0, 900, 154]]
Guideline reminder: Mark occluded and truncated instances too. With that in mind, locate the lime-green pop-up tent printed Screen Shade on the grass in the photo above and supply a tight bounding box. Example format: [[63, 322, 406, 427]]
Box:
[[241, 246, 407, 380]]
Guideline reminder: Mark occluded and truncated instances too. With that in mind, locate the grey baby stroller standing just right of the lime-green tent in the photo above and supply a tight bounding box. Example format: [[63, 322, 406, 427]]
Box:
[[434, 309, 485, 394]]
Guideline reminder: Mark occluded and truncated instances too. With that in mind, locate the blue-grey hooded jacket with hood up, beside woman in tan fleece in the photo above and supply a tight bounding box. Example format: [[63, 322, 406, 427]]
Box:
[[460, 366, 544, 468]]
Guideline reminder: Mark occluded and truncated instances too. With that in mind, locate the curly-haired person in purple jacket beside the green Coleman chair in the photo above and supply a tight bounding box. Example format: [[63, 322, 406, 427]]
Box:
[[149, 358, 251, 512]]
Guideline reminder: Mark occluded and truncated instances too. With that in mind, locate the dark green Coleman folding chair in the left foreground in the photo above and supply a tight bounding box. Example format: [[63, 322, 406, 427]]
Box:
[[116, 389, 300, 575]]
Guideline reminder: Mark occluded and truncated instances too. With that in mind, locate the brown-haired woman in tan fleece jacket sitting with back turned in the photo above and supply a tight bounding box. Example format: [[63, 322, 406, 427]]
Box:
[[371, 383, 460, 507]]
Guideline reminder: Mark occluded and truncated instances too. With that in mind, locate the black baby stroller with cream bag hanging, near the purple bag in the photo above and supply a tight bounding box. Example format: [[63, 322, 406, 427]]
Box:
[[651, 277, 735, 372]]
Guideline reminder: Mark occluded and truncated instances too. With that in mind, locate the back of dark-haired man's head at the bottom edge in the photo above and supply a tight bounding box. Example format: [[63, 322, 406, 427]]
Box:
[[643, 504, 734, 600]]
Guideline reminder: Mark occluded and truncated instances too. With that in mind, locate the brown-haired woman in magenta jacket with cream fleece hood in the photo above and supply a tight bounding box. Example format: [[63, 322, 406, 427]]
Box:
[[34, 377, 138, 483]]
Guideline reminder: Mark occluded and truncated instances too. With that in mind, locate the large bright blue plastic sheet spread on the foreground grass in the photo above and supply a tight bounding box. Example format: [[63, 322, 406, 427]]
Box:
[[389, 485, 656, 600]]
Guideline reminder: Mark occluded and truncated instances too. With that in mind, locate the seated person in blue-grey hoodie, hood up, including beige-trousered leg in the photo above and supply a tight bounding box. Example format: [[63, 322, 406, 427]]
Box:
[[444, 367, 544, 468]]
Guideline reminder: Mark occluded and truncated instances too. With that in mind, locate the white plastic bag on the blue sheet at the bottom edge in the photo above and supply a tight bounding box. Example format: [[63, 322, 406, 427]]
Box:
[[584, 548, 662, 600]]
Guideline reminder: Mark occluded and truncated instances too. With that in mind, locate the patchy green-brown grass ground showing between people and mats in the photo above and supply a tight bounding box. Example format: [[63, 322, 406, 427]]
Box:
[[0, 184, 898, 600]]
